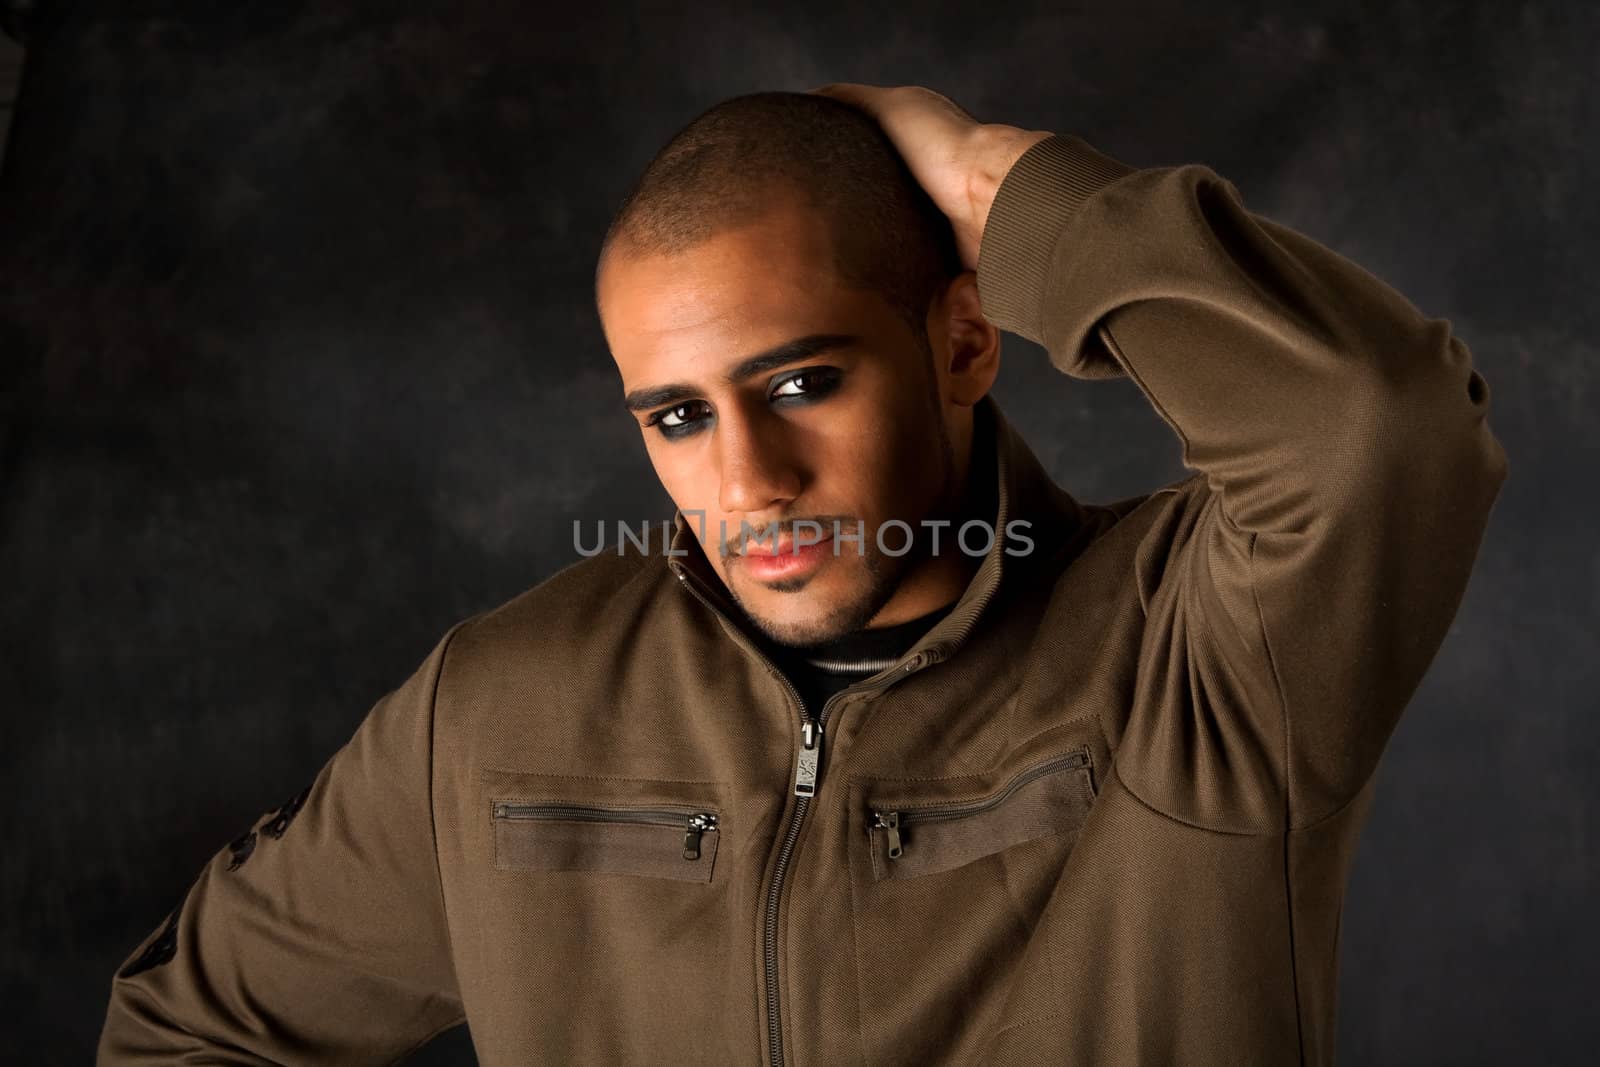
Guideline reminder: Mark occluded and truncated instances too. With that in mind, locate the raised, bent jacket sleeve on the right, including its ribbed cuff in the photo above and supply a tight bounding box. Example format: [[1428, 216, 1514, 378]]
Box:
[[978, 136, 1507, 832]]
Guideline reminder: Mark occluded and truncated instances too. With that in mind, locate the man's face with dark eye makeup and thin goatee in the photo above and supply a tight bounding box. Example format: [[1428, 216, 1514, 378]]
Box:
[[597, 191, 955, 645]]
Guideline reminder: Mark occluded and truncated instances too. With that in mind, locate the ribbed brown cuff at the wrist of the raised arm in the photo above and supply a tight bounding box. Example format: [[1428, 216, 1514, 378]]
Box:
[[978, 134, 1138, 344]]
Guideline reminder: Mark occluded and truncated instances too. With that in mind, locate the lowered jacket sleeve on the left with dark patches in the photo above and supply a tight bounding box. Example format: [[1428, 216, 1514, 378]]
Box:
[[98, 630, 462, 1064]]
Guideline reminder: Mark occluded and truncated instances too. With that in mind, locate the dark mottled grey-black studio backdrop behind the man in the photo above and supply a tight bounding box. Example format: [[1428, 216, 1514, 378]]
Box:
[[0, 0, 1600, 1064]]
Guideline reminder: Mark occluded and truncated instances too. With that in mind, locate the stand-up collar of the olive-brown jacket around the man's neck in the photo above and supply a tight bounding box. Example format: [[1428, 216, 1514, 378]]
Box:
[[667, 395, 1082, 667]]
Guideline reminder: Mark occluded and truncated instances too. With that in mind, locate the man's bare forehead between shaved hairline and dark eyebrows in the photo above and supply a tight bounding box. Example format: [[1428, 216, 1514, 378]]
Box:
[[595, 202, 886, 389]]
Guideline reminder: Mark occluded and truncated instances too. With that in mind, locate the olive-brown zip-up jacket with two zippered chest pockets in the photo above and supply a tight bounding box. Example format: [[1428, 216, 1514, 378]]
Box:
[[101, 136, 1507, 1067]]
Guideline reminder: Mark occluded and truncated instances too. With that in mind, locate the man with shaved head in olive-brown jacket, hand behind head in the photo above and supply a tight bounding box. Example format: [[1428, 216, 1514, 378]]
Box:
[[101, 85, 1507, 1064]]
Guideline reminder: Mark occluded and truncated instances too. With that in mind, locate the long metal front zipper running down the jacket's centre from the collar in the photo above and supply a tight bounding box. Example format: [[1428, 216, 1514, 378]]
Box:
[[678, 571, 939, 1067]]
